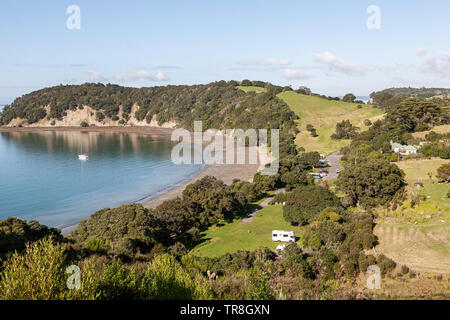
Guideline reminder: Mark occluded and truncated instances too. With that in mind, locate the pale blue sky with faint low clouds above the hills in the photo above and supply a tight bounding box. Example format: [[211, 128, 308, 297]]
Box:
[[0, 0, 450, 105]]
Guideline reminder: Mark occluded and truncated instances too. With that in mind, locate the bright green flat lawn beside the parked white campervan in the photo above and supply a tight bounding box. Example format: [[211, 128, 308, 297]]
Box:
[[193, 205, 302, 257]]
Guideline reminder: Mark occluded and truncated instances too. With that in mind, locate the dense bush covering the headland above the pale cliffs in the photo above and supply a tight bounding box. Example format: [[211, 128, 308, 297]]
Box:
[[0, 81, 297, 139]]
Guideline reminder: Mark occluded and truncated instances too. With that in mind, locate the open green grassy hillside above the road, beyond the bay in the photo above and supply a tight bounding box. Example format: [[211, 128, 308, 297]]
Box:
[[278, 91, 383, 154]]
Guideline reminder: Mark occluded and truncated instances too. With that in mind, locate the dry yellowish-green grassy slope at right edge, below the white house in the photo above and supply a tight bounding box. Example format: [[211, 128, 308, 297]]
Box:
[[375, 158, 450, 274]]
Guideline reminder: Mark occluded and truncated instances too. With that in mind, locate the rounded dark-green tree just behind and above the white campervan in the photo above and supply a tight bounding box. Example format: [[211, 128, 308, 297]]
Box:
[[283, 185, 341, 224]]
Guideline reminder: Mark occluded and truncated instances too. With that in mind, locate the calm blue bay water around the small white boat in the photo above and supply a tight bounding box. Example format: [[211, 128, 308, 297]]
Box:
[[0, 131, 202, 228]]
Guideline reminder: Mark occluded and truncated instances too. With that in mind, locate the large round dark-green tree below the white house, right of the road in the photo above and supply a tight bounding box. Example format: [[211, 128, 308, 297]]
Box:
[[336, 155, 406, 208]]
